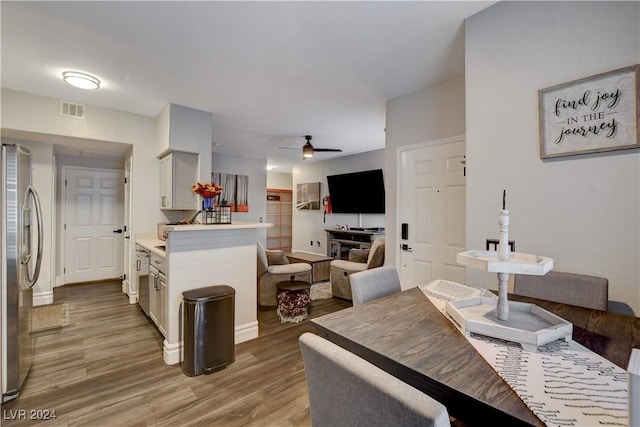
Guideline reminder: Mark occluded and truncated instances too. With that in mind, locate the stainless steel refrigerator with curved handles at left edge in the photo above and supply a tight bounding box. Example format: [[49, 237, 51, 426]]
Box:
[[0, 142, 42, 403]]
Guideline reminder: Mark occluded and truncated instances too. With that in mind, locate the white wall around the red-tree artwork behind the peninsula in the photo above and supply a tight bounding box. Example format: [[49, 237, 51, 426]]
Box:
[[209, 153, 267, 242]]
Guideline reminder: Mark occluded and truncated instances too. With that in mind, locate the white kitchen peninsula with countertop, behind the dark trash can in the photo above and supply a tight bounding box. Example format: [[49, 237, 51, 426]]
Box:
[[136, 222, 271, 365]]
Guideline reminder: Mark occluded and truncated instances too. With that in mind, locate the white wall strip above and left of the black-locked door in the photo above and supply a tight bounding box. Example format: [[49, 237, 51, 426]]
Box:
[[384, 77, 465, 265]]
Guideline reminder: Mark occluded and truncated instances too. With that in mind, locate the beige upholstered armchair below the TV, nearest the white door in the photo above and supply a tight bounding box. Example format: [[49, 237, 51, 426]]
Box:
[[330, 237, 384, 300]]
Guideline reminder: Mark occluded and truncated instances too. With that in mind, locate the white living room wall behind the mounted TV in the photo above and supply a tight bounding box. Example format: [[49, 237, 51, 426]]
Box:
[[292, 150, 384, 255]]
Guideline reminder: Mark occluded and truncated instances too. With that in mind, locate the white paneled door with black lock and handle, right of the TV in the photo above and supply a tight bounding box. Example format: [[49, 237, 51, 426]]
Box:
[[398, 139, 466, 286]]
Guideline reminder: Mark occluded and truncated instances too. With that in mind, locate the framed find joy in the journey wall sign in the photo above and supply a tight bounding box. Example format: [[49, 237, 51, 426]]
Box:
[[538, 65, 640, 159]]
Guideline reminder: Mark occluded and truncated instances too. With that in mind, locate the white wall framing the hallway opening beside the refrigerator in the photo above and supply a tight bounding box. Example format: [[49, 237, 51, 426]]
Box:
[[1, 89, 164, 303]]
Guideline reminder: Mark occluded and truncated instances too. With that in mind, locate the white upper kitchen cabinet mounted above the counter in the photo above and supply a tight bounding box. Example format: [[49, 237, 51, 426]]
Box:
[[160, 151, 198, 210]]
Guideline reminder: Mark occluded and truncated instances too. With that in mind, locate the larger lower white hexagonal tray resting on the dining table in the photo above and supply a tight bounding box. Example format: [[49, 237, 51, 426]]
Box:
[[446, 298, 573, 351]]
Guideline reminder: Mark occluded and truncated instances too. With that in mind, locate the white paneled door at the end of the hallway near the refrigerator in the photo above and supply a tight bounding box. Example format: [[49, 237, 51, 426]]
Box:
[[64, 168, 124, 283]]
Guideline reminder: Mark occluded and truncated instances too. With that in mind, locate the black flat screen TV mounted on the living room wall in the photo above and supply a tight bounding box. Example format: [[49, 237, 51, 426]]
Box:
[[327, 169, 384, 214]]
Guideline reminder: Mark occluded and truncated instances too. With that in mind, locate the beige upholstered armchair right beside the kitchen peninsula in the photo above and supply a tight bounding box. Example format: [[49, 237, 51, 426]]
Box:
[[257, 240, 311, 306]]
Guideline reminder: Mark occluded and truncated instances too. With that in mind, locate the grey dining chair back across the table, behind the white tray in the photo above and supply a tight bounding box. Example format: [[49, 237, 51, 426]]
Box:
[[513, 271, 609, 311]]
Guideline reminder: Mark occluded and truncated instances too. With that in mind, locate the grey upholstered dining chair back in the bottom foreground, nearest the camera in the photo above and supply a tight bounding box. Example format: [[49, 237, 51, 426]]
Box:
[[299, 332, 451, 427]]
